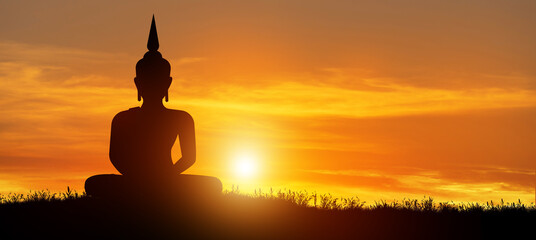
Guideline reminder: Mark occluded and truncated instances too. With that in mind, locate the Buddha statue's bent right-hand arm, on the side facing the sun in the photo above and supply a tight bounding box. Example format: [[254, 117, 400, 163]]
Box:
[[175, 112, 196, 173]]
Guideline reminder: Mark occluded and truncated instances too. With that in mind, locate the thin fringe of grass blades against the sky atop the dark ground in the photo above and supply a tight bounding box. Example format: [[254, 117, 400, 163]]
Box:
[[0, 187, 536, 213]]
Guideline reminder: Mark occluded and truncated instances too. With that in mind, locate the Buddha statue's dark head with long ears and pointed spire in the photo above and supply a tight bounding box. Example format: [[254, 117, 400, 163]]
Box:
[[134, 15, 172, 102]]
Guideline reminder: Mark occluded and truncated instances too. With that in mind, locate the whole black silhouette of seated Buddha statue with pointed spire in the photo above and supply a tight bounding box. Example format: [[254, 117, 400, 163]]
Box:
[[85, 16, 222, 197]]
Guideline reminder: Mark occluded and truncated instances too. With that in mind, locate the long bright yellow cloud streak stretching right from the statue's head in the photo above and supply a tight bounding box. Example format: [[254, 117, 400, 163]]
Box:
[[170, 79, 536, 118]]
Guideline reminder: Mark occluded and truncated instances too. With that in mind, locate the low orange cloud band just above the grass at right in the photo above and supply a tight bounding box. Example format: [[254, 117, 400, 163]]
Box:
[[302, 168, 535, 203]]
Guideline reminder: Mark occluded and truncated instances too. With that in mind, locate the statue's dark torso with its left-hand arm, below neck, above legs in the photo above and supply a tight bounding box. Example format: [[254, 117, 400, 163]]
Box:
[[110, 107, 191, 177]]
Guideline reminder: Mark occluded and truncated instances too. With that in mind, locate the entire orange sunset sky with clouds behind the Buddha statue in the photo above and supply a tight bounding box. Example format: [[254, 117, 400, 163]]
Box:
[[0, 0, 536, 203]]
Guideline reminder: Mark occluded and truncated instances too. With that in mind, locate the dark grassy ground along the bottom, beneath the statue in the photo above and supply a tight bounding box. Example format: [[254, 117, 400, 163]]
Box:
[[0, 188, 536, 239]]
